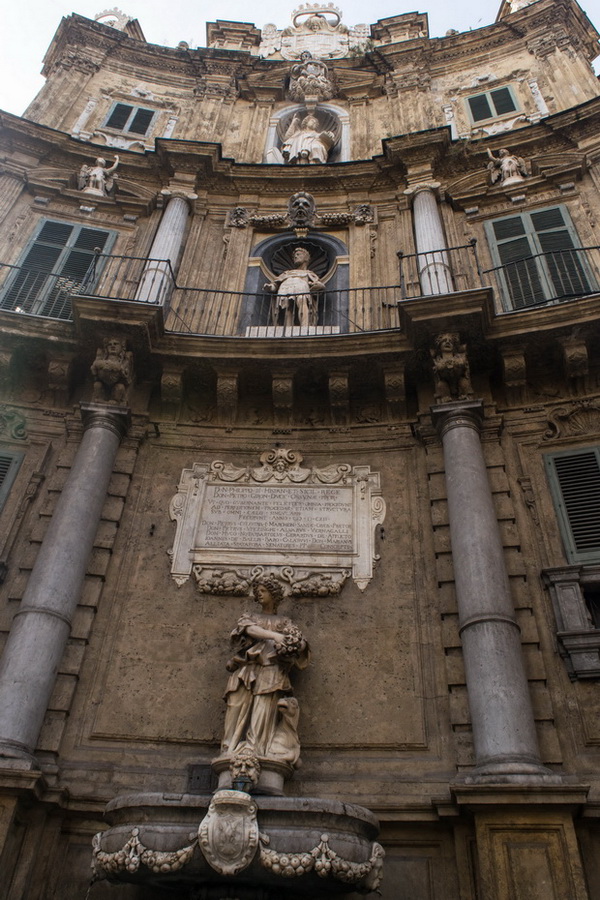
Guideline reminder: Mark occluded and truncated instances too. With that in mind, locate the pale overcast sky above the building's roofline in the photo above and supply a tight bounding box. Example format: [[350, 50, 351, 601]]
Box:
[[0, 0, 600, 115]]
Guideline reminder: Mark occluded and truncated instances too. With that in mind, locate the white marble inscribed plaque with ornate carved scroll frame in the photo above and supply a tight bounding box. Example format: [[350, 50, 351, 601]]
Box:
[[170, 448, 385, 597]]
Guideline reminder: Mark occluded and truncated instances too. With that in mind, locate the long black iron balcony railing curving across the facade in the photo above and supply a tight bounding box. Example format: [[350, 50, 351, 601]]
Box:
[[0, 240, 600, 338]]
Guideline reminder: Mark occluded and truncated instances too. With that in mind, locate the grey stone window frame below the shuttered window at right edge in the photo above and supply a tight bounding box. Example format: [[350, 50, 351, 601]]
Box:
[[542, 564, 600, 681]]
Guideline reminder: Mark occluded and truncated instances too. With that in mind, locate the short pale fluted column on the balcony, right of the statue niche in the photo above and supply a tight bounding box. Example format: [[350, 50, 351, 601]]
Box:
[[404, 181, 454, 295]]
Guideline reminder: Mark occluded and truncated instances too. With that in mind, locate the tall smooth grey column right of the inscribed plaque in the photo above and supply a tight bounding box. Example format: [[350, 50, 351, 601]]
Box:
[[432, 400, 555, 781]]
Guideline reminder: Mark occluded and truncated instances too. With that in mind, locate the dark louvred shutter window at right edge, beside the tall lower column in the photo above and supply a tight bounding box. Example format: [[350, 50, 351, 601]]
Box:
[[545, 447, 600, 563]]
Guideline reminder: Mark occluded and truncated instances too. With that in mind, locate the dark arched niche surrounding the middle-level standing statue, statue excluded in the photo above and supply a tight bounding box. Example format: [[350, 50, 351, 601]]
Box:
[[240, 231, 349, 336]]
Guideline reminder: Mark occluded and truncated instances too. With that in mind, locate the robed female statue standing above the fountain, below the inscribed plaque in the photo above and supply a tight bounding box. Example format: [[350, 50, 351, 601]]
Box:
[[221, 576, 309, 767]]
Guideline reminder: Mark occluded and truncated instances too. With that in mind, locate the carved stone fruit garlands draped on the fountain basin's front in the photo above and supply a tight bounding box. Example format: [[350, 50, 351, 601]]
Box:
[[92, 828, 385, 893]]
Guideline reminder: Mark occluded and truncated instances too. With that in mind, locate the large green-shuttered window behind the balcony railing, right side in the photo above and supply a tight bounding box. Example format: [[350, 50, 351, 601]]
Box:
[[485, 206, 596, 309]]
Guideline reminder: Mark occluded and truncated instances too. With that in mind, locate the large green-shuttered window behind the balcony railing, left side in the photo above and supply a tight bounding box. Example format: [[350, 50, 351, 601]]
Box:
[[0, 219, 115, 320]]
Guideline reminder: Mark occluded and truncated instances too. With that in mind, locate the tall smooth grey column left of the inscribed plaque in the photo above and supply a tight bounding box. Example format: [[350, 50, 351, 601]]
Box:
[[0, 403, 129, 765]]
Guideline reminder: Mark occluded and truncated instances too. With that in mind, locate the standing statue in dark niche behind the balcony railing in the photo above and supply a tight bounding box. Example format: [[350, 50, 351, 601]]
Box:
[[264, 247, 325, 328]]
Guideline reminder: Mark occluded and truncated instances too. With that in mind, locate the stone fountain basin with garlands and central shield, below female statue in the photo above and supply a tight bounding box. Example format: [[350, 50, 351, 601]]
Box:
[[93, 790, 384, 900]]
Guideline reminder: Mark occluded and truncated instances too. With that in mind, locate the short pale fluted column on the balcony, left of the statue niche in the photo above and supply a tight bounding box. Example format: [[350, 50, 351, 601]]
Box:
[[135, 191, 197, 305]]
